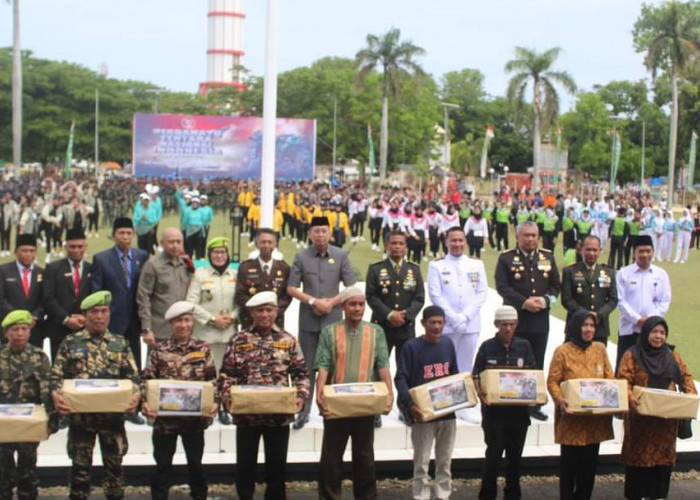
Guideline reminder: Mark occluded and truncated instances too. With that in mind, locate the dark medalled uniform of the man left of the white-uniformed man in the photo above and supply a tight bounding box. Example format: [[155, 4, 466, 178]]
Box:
[[365, 258, 425, 365]]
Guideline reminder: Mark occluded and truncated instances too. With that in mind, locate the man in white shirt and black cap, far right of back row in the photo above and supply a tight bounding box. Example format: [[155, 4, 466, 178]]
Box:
[[615, 234, 671, 372]]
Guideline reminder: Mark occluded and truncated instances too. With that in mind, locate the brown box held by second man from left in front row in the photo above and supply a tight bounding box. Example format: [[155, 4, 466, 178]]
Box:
[[63, 378, 134, 413]]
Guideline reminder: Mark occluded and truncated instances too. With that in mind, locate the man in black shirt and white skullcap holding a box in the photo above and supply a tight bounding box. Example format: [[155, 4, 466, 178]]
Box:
[[472, 306, 536, 500]]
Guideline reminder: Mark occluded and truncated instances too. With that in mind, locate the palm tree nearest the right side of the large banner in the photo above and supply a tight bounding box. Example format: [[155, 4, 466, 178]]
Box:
[[355, 28, 425, 182]]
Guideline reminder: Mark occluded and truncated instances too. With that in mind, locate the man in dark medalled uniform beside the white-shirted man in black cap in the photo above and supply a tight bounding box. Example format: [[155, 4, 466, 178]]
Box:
[[561, 235, 617, 345]]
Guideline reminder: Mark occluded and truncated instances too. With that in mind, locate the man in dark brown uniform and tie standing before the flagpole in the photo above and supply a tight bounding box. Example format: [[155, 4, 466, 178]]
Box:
[[233, 228, 292, 330]]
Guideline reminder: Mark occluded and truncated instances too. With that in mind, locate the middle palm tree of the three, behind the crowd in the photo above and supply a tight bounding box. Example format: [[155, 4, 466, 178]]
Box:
[[505, 47, 576, 191]]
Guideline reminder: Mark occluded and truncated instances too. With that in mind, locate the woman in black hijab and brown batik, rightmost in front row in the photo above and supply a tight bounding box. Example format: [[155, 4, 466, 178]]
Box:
[[618, 316, 696, 499]]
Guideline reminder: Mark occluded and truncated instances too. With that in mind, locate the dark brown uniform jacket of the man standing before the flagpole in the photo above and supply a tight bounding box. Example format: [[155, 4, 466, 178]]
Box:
[[233, 259, 292, 330]]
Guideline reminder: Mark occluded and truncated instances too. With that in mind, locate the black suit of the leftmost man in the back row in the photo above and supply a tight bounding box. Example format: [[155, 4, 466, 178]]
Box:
[[0, 260, 44, 348]]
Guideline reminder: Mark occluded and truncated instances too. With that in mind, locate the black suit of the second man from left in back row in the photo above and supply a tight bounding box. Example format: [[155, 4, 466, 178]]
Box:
[[44, 258, 92, 360]]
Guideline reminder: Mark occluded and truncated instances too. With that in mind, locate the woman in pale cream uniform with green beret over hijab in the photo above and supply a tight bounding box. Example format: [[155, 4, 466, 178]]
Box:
[[187, 238, 237, 425]]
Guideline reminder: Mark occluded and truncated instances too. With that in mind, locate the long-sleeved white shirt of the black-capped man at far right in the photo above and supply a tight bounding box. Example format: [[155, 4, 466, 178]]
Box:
[[616, 263, 671, 335]]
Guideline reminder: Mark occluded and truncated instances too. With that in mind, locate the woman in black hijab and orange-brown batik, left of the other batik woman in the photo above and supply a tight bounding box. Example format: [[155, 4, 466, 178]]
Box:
[[547, 309, 615, 499]]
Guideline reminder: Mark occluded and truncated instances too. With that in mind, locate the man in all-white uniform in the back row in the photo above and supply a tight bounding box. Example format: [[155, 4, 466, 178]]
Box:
[[428, 227, 488, 423]]
